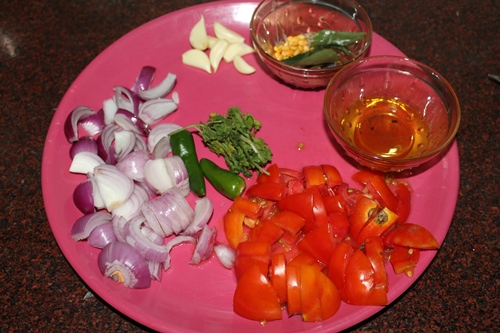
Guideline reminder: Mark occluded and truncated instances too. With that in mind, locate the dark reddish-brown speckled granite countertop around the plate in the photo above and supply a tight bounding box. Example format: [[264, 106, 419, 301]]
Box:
[[0, 0, 500, 332]]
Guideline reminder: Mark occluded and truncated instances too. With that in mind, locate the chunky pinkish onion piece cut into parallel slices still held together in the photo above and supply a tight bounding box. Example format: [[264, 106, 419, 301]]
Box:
[[142, 189, 194, 237]]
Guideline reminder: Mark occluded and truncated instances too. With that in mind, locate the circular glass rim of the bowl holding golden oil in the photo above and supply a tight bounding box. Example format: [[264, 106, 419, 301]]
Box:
[[323, 55, 462, 167]]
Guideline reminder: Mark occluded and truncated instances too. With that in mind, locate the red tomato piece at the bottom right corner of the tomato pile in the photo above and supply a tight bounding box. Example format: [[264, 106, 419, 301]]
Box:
[[341, 250, 387, 305]]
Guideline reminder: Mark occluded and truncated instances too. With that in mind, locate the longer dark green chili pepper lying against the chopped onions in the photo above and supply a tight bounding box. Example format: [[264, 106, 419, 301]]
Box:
[[170, 129, 206, 197]]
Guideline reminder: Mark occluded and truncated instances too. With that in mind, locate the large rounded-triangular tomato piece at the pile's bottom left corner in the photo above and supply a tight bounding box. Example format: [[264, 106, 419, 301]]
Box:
[[233, 266, 282, 322]]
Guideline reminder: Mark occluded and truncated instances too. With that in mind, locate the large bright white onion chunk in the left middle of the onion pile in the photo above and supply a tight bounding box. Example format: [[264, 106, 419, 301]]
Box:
[[94, 164, 134, 212]]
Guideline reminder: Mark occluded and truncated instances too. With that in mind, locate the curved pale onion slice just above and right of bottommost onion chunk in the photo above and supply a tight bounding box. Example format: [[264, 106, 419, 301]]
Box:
[[125, 215, 168, 263]]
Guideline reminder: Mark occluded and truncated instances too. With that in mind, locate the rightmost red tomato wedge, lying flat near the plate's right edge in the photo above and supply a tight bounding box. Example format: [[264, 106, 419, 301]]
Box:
[[384, 223, 439, 250]]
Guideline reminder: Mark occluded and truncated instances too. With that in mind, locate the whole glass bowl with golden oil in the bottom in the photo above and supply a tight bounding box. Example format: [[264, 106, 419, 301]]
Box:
[[324, 56, 460, 172]]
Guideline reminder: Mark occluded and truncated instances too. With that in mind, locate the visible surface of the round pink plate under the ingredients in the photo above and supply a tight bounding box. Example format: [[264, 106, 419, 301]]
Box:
[[42, 1, 459, 333]]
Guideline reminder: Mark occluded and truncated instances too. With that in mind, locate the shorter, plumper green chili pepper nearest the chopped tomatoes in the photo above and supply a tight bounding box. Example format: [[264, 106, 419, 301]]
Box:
[[200, 158, 246, 199]]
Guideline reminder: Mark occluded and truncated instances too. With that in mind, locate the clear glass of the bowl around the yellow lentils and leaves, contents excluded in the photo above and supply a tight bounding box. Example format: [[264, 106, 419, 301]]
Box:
[[250, 0, 372, 89]]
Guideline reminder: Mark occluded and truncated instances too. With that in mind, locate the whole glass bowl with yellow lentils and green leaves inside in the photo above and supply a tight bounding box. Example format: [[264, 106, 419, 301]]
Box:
[[250, 0, 372, 89]]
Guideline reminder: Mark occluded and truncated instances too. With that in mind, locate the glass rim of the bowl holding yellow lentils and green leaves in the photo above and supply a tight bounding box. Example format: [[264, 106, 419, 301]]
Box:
[[250, 0, 373, 76]]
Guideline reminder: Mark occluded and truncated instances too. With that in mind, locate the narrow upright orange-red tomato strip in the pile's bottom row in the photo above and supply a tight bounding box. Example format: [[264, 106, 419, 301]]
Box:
[[299, 265, 323, 322]]
